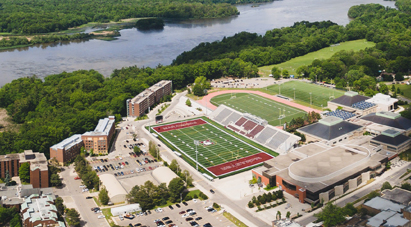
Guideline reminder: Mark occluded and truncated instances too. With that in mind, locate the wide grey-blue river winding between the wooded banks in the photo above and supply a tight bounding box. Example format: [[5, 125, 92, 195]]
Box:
[[0, 0, 395, 86]]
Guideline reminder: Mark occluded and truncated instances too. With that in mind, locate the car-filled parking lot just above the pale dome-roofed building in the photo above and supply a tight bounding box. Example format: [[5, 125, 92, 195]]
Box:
[[90, 152, 160, 179]]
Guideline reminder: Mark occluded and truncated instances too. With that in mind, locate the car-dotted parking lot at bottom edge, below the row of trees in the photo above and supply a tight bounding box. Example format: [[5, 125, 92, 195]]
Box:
[[114, 200, 235, 227]]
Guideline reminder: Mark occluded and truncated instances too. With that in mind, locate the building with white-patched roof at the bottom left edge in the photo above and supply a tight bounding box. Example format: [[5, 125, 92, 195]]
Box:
[[20, 194, 66, 227]]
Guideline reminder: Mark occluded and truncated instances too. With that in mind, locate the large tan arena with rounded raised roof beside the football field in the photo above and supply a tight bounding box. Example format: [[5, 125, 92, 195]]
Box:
[[252, 143, 389, 204]]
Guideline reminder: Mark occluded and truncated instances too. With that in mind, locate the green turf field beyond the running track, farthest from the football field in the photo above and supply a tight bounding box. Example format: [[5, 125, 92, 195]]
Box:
[[267, 81, 345, 108]]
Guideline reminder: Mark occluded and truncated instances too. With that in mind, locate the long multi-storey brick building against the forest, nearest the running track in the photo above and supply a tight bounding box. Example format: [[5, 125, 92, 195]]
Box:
[[126, 80, 172, 117]]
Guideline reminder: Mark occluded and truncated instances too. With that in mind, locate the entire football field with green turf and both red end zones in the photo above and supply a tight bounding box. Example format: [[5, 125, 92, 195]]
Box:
[[152, 119, 273, 177]]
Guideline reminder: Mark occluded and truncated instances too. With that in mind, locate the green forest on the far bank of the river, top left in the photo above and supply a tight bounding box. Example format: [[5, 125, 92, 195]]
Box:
[[0, 0, 271, 34]]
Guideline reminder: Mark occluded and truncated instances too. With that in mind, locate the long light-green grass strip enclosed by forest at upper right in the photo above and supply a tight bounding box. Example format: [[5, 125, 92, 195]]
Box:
[[259, 39, 375, 76]]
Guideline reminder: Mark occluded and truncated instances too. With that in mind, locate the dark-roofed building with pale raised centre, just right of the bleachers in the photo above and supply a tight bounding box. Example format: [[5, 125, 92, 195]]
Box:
[[297, 116, 364, 145]]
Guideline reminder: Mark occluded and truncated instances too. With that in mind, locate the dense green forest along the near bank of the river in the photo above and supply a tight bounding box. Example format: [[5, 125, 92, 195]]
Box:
[[0, 0, 411, 156]]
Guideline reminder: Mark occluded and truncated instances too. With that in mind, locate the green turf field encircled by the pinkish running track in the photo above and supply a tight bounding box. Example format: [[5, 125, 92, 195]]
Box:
[[211, 93, 306, 126]]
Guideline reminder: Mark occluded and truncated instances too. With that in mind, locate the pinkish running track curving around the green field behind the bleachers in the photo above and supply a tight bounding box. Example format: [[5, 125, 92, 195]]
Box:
[[197, 90, 321, 113]]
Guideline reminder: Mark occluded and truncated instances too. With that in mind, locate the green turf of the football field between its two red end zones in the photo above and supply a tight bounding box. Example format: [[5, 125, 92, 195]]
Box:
[[154, 120, 261, 168]]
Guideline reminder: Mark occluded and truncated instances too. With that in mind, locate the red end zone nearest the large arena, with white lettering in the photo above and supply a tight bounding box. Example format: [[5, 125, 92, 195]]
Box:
[[207, 152, 273, 176]]
